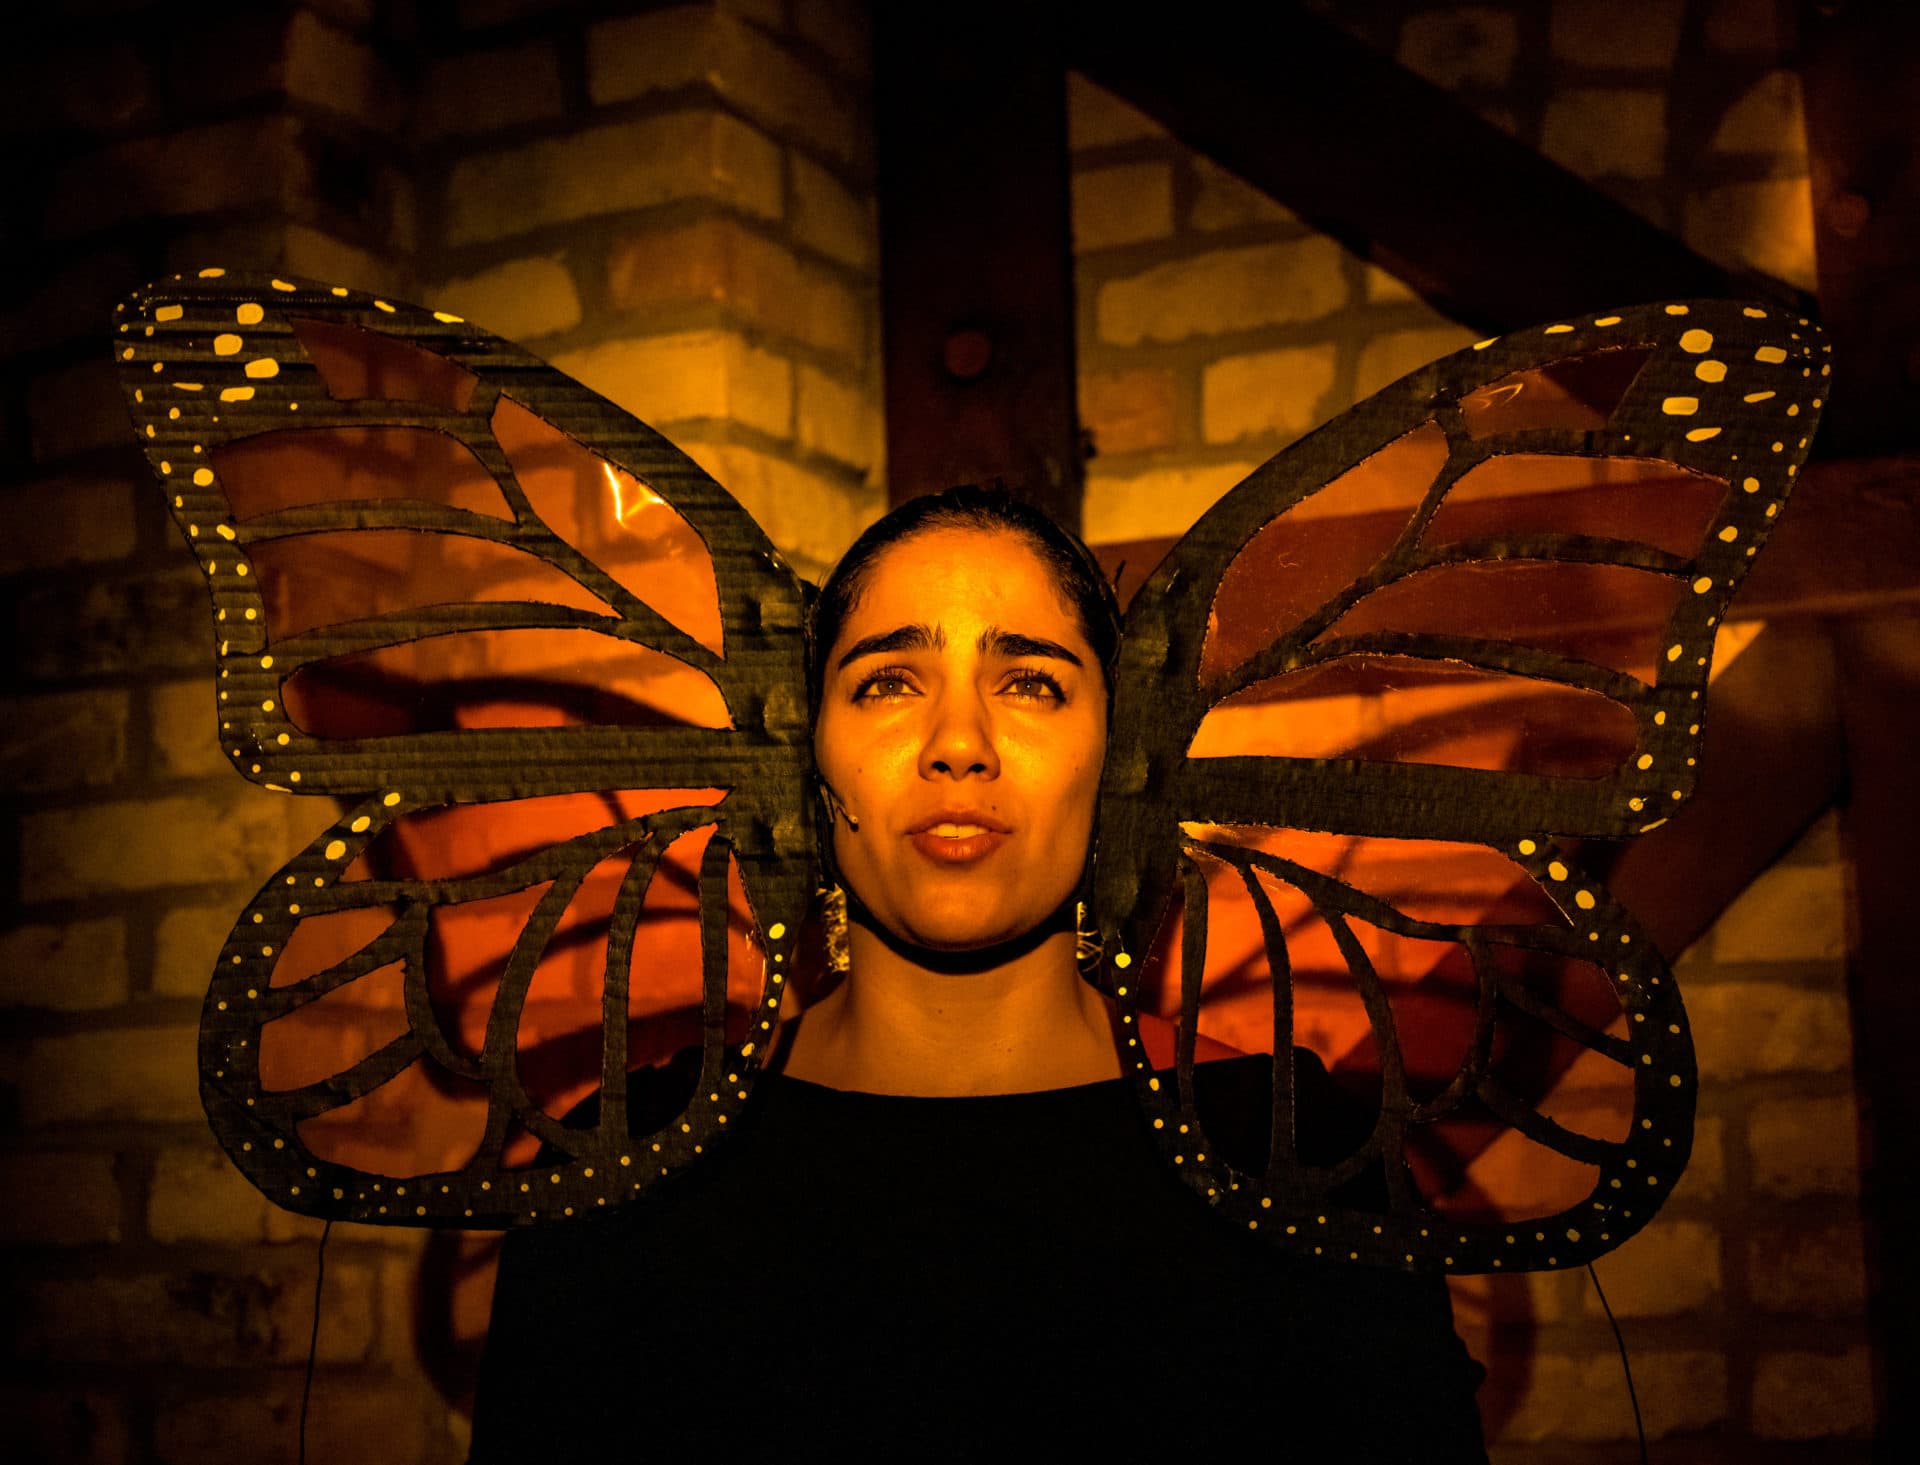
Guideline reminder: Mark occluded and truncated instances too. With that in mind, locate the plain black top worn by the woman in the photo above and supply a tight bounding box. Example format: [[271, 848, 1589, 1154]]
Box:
[[472, 1058, 1486, 1465]]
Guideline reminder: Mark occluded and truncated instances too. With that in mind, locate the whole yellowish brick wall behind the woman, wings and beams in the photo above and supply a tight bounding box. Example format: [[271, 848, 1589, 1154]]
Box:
[[0, 0, 1866, 1465]]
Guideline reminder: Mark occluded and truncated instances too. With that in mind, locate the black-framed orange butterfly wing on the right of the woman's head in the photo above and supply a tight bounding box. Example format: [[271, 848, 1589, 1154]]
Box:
[[1094, 301, 1830, 1271]]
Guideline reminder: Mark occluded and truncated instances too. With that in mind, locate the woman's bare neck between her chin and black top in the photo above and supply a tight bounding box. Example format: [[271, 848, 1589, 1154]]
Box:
[[785, 920, 1119, 1098]]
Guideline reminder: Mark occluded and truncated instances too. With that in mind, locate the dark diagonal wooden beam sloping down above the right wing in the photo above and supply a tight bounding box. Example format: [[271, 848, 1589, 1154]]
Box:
[[1068, 0, 1803, 334]]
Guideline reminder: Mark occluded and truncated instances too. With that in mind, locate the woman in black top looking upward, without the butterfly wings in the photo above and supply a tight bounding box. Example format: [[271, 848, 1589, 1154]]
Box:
[[474, 490, 1484, 1461]]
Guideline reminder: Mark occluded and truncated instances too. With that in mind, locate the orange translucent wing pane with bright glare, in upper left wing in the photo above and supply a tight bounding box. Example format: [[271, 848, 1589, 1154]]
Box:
[[493, 397, 724, 655]]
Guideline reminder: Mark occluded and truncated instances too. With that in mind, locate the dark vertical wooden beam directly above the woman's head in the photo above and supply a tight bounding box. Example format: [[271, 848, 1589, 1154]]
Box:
[[874, 0, 1083, 530]]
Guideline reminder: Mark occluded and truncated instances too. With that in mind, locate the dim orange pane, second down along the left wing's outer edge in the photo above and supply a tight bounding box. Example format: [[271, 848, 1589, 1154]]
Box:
[[213, 426, 513, 520]]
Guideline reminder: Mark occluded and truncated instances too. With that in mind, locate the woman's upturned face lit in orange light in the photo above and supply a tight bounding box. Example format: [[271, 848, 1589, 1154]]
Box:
[[814, 530, 1106, 950]]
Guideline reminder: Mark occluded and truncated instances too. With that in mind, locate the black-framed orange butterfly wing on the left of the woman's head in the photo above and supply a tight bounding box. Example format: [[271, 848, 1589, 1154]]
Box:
[[113, 271, 814, 1225]]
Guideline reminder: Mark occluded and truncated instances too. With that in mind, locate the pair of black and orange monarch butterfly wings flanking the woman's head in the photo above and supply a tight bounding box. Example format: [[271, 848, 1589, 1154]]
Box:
[[115, 271, 1828, 1271]]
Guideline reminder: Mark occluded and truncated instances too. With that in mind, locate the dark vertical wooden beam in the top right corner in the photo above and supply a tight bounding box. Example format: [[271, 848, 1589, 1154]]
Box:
[[1803, 4, 1920, 457]]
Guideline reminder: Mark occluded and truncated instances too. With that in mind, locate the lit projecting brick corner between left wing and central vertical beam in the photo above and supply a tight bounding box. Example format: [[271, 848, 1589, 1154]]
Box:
[[417, 0, 885, 574]]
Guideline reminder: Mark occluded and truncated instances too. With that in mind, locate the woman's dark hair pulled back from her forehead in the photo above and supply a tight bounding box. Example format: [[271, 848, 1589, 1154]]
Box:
[[806, 484, 1119, 716]]
